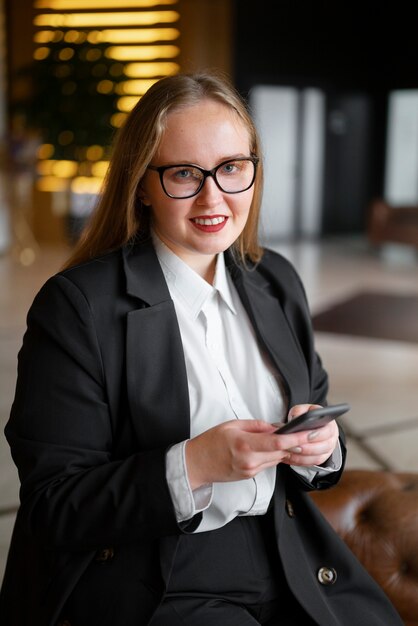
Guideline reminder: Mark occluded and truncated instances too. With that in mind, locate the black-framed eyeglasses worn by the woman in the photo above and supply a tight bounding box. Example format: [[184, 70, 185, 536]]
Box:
[[148, 157, 259, 199]]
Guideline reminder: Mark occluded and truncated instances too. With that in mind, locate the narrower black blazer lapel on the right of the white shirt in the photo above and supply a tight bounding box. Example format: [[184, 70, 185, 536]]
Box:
[[230, 258, 310, 406]]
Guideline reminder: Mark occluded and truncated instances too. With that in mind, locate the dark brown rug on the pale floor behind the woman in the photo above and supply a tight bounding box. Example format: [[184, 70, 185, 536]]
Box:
[[313, 292, 418, 343]]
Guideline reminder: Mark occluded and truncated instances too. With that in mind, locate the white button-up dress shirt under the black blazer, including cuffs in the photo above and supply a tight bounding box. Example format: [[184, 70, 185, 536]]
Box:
[[153, 234, 341, 532]]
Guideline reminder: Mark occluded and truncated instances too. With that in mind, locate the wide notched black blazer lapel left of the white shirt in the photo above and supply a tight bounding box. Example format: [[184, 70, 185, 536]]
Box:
[[124, 242, 190, 449]]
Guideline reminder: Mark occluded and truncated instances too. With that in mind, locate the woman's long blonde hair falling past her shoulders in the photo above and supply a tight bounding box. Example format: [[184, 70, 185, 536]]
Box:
[[65, 72, 263, 268]]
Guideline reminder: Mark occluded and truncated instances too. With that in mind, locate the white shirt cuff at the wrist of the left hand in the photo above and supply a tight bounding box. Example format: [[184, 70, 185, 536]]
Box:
[[166, 440, 213, 522]]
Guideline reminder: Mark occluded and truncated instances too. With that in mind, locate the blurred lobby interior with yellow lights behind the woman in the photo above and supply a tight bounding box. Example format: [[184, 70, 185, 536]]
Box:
[[0, 0, 418, 579]]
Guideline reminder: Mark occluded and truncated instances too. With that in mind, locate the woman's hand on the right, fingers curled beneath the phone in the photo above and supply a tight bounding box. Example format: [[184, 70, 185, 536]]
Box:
[[281, 404, 339, 466]]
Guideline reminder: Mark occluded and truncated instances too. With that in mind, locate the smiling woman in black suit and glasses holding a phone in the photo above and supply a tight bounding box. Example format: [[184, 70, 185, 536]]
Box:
[[0, 74, 401, 626]]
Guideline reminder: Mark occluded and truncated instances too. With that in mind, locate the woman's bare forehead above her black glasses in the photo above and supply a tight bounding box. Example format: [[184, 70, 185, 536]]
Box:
[[158, 99, 250, 163]]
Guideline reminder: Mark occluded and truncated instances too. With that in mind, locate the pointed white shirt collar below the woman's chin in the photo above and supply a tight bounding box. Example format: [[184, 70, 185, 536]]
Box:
[[152, 232, 236, 319]]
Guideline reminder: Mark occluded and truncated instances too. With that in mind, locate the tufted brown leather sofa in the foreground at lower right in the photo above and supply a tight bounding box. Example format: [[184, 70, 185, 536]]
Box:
[[312, 469, 418, 626]]
